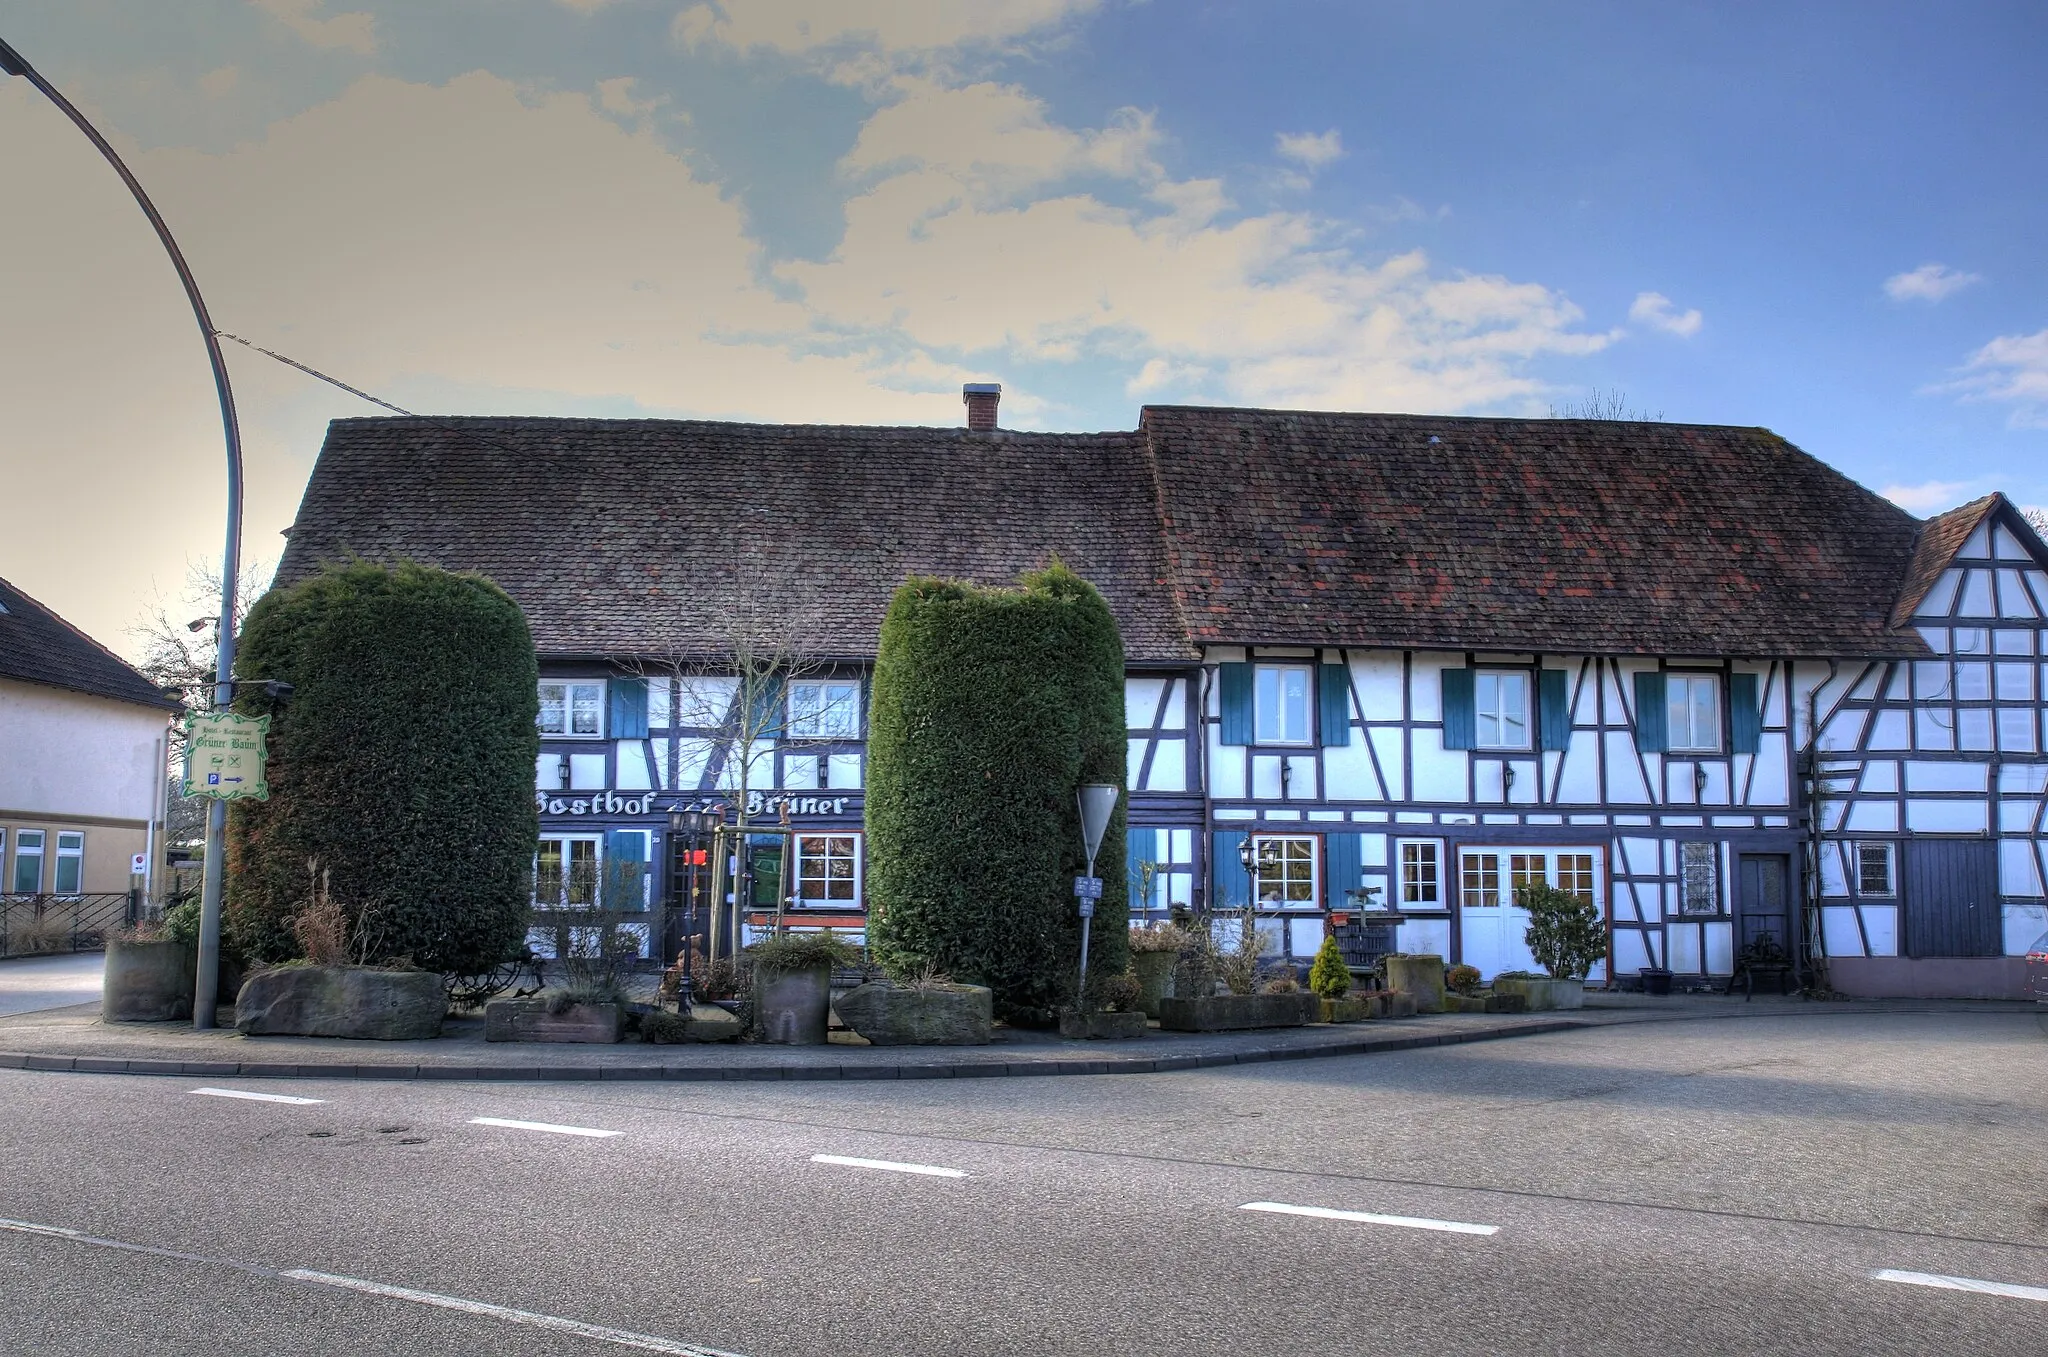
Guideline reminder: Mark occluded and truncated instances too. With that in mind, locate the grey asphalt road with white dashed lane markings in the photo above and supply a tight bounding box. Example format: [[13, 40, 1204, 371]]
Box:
[[0, 1011, 2048, 1357]]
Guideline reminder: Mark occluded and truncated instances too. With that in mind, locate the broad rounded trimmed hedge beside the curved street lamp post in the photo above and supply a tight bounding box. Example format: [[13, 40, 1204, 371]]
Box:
[[225, 563, 541, 974]]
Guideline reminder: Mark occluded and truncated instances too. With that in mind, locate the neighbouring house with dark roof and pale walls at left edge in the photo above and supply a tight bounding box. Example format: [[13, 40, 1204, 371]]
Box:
[[0, 579, 178, 905]]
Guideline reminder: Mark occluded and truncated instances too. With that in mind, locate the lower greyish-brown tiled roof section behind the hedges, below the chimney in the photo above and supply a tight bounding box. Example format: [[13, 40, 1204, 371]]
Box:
[[279, 418, 1192, 661]]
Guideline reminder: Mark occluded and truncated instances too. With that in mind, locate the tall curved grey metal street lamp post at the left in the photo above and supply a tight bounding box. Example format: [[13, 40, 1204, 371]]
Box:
[[0, 41, 242, 1027]]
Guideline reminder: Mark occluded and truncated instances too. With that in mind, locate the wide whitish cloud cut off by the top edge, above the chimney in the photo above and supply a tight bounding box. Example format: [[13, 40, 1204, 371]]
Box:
[[670, 0, 1100, 55]]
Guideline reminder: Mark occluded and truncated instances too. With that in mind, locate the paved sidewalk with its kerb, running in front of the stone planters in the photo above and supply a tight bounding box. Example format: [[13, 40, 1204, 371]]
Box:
[[0, 995, 2034, 1081]]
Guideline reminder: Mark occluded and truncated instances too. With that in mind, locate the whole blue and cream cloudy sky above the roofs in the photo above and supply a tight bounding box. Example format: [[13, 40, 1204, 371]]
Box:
[[0, 0, 2048, 647]]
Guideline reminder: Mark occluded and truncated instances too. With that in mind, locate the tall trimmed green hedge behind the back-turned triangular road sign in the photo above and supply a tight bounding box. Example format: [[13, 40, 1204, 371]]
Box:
[[866, 563, 1128, 1019]]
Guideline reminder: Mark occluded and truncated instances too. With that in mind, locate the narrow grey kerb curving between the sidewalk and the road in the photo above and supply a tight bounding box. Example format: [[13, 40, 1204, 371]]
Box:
[[0, 1019, 1599, 1083]]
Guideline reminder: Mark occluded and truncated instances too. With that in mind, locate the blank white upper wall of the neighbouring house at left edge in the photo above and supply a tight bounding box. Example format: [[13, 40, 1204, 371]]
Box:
[[0, 680, 168, 821]]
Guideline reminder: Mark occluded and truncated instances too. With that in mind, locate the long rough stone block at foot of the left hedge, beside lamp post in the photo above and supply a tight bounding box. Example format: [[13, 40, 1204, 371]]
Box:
[[236, 966, 449, 1042]]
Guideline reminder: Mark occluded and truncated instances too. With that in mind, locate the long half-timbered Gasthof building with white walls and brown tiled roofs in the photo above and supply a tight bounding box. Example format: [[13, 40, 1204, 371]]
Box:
[[281, 389, 2048, 993]]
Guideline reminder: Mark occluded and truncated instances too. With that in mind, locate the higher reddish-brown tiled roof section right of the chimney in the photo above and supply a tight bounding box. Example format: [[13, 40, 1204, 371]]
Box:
[[1141, 405, 1925, 657]]
